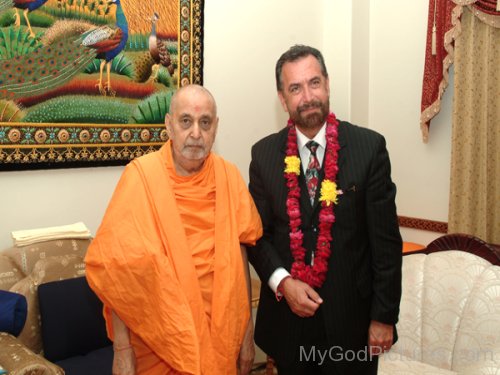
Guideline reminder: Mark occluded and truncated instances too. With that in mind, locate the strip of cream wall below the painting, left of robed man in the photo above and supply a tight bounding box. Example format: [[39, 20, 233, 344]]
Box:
[[0, 167, 123, 249]]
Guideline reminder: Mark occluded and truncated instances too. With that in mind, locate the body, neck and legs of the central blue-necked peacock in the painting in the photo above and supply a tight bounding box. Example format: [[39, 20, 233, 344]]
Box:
[[82, 0, 128, 96]]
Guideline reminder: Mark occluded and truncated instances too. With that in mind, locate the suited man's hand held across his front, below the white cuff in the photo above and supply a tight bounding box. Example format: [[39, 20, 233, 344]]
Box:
[[280, 277, 323, 318]]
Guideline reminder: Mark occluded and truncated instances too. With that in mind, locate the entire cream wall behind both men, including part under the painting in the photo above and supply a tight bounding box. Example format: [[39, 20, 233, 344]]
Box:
[[0, 0, 451, 248]]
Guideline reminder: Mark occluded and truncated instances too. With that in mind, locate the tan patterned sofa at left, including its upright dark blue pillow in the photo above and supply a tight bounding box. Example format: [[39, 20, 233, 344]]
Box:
[[0, 239, 112, 375]]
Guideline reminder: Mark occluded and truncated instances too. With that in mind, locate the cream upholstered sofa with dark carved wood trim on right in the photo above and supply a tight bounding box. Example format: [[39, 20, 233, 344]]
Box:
[[379, 234, 500, 375]]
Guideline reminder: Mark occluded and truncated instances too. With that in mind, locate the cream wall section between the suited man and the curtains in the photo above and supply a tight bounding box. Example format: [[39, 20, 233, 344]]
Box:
[[368, 0, 453, 244]]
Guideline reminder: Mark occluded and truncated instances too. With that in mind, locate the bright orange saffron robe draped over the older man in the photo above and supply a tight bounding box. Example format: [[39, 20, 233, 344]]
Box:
[[85, 141, 262, 375]]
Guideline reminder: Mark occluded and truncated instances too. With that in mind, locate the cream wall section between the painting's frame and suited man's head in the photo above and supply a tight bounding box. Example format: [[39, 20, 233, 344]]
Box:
[[204, 0, 323, 162]]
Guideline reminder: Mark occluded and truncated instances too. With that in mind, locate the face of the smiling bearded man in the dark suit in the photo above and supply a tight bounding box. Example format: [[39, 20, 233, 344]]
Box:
[[278, 55, 330, 131]]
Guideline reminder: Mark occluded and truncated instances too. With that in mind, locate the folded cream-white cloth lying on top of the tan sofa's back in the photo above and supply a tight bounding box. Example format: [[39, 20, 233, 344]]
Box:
[[12, 222, 91, 246]]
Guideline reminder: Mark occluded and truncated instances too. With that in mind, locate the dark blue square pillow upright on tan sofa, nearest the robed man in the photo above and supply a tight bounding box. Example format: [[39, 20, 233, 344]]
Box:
[[38, 277, 111, 362]]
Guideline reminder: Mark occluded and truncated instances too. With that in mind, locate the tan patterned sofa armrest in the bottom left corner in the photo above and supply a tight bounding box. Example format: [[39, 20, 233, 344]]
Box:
[[0, 332, 64, 375]]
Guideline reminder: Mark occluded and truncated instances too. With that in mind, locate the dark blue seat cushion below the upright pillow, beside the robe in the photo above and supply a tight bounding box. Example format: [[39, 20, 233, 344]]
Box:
[[56, 346, 113, 375]]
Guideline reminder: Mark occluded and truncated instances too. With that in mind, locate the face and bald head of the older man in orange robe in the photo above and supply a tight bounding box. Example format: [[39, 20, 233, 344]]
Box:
[[165, 89, 219, 168]]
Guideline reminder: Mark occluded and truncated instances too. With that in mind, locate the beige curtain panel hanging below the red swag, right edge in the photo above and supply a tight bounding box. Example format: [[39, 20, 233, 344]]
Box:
[[448, 7, 500, 244]]
